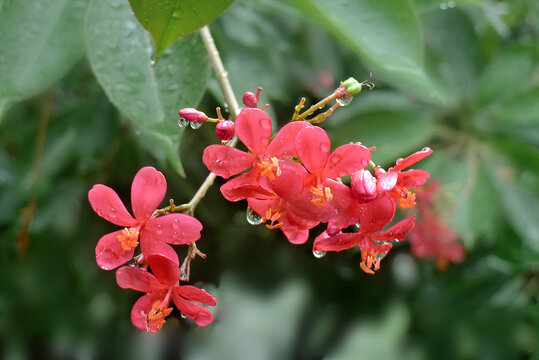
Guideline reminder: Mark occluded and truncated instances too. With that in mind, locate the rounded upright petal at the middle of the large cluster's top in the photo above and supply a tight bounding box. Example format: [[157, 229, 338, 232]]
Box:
[[295, 126, 331, 174]]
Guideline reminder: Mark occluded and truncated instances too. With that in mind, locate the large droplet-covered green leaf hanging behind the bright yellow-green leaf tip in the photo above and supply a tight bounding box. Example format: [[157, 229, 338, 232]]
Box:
[[86, 1, 210, 174]]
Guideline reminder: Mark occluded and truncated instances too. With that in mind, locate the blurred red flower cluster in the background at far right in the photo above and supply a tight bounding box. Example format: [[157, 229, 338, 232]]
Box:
[[410, 181, 464, 271]]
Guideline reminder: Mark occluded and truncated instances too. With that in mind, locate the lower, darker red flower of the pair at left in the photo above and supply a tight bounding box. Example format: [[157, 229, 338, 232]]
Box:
[[116, 254, 217, 333]]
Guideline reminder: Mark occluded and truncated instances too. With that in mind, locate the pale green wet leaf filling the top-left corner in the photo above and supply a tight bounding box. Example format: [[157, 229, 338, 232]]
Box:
[[0, 0, 88, 116]]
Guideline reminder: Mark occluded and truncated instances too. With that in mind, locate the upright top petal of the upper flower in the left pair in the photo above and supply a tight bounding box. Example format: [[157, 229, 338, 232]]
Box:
[[131, 166, 167, 222]]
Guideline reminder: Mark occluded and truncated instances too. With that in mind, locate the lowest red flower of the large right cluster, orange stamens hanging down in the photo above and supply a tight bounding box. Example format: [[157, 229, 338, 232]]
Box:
[[313, 197, 415, 274]]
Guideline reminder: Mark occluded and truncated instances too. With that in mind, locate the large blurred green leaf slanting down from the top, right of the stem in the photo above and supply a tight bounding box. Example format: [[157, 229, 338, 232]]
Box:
[[297, 0, 442, 101]]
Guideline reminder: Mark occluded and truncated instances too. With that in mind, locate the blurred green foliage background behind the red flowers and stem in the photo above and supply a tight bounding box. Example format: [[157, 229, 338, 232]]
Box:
[[0, 0, 539, 359]]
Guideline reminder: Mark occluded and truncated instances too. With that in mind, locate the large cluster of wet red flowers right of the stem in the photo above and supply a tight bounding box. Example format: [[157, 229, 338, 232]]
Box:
[[203, 95, 432, 273]]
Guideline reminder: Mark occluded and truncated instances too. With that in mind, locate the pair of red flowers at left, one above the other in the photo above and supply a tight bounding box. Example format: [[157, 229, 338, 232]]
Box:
[[88, 167, 216, 332]]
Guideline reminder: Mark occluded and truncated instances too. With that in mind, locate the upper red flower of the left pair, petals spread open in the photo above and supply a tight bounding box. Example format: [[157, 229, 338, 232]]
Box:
[[88, 167, 202, 270]]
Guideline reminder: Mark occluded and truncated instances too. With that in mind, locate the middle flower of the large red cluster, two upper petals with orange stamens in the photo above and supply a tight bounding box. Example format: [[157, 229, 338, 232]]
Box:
[[295, 126, 371, 207]]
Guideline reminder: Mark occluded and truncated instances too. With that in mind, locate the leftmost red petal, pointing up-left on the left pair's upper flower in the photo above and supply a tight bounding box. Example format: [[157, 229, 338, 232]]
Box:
[[88, 184, 137, 227]]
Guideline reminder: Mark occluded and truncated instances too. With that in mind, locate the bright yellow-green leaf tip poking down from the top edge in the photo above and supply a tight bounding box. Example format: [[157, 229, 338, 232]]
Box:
[[129, 0, 234, 59]]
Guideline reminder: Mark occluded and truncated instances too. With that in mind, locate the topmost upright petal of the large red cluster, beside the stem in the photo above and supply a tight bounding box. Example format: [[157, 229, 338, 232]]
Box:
[[236, 108, 271, 154]]
